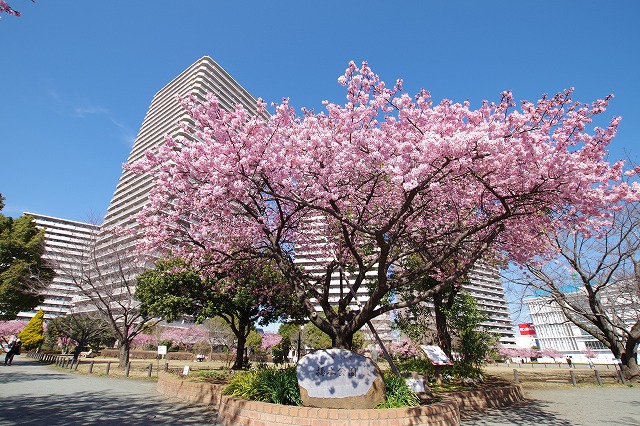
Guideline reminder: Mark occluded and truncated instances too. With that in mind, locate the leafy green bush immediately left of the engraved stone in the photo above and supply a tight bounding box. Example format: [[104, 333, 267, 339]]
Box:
[[224, 367, 302, 405]]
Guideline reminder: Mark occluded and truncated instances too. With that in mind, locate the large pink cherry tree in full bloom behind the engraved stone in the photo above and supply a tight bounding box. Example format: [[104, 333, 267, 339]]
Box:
[[127, 63, 638, 348]]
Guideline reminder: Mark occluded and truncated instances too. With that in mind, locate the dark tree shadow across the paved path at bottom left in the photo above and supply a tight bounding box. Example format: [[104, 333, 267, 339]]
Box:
[[0, 392, 216, 426]]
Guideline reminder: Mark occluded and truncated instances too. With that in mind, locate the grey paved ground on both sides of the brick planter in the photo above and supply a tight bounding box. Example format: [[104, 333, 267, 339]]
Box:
[[0, 356, 640, 426]]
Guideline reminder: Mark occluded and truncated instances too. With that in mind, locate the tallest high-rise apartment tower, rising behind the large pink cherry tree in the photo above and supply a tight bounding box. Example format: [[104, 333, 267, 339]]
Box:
[[69, 56, 268, 311]]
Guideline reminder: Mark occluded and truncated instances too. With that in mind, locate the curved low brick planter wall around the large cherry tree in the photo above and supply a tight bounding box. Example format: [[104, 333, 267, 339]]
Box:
[[157, 372, 524, 426]]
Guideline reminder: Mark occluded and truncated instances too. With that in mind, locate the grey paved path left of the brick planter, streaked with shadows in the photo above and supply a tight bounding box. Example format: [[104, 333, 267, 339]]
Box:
[[0, 356, 215, 426]]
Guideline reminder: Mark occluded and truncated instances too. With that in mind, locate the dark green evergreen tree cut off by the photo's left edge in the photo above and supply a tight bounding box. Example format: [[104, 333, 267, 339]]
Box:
[[0, 194, 53, 320]]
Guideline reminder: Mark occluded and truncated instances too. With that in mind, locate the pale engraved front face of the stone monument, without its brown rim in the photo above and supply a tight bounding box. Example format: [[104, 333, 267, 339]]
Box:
[[296, 349, 381, 399]]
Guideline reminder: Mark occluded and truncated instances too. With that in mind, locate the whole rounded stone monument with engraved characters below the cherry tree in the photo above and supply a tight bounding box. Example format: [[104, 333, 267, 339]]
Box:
[[296, 349, 385, 409]]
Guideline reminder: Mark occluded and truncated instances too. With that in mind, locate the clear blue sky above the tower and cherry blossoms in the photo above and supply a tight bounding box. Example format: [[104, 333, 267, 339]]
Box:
[[0, 0, 640, 221]]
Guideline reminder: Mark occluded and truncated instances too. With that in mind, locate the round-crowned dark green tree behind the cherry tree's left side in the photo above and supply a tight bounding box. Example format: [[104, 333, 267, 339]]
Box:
[[135, 259, 296, 370]]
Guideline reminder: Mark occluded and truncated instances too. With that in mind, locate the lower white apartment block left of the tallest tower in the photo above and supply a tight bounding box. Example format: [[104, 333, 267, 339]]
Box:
[[18, 213, 99, 319]]
